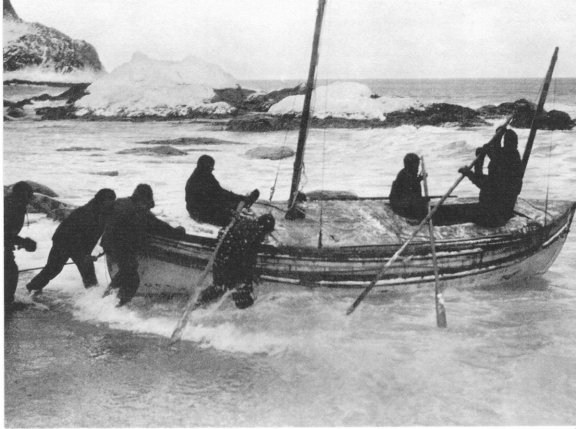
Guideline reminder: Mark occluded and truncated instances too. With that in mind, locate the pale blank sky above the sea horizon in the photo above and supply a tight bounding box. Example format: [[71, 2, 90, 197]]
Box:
[[12, 0, 576, 79]]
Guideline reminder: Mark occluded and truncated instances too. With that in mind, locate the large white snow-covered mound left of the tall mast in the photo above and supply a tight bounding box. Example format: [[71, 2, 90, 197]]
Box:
[[76, 53, 237, 117]]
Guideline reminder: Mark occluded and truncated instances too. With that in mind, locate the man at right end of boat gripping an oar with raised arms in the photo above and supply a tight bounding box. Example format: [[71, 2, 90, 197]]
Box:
[[458, 130, 522, 227]]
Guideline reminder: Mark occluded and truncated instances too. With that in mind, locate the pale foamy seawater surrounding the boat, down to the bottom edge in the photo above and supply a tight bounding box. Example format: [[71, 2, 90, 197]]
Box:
[[3, 79, 576, 427]]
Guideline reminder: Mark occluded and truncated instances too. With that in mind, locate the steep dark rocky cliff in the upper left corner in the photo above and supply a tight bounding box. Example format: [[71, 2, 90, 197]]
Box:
[[3, 0, 103, 77]]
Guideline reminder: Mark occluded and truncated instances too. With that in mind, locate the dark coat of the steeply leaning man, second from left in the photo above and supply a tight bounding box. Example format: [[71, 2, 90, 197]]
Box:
[[52, 199, 105, 255]]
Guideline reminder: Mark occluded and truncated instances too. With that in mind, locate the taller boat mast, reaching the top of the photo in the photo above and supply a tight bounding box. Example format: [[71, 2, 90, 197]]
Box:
[[288, 0, 326, 208]]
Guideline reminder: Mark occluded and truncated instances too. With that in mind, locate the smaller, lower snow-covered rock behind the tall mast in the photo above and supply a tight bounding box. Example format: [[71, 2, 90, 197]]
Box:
[[268, 82, 421, 121]]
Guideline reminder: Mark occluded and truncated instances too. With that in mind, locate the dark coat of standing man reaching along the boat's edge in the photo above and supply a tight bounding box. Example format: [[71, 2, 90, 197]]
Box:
[[102, 197, 182, 255]]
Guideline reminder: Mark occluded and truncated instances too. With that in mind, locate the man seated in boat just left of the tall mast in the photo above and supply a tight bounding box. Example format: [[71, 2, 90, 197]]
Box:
[[186, 155, 260, 226]]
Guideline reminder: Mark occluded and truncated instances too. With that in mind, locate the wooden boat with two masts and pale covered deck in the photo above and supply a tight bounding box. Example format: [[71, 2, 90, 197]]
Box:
[[108, 0, 576, 295]]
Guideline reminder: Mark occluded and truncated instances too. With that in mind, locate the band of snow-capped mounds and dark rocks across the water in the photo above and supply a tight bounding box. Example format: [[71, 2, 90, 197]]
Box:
[[4, 53, 575, 131]]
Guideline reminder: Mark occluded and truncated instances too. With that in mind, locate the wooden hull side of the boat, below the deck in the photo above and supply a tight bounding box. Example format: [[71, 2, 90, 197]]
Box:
[[108, 199, 576, 295]]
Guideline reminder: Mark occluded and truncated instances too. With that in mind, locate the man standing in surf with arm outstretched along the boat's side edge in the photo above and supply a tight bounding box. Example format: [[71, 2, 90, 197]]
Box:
[[102, 184, 186, 307]]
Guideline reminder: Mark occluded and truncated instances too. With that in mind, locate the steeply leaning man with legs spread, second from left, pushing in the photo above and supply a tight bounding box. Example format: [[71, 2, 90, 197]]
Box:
[[26, 189, 116, 293]]
